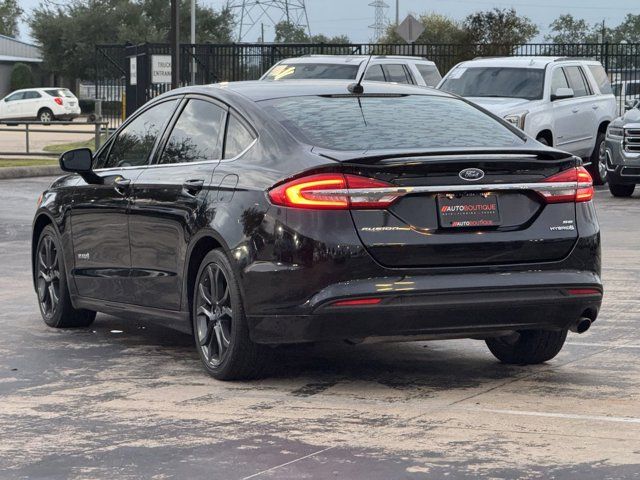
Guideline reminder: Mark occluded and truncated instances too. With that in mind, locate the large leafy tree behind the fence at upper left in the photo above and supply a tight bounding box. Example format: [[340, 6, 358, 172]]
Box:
[[28, 0, 233, 79]]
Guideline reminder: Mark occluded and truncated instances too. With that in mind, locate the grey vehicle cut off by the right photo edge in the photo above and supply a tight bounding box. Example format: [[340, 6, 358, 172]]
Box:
[[606, 100, 640, 197]]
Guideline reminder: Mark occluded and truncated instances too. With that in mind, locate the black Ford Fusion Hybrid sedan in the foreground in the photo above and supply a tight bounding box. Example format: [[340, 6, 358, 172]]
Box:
[[32, 81, 602, 379]]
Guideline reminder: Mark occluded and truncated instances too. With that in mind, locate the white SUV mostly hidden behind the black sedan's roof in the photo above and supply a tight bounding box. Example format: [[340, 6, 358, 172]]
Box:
[[260, 55, 442, 87]]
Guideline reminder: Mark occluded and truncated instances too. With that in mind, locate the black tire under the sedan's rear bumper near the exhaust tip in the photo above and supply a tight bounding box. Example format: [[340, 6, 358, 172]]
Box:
[[486, 329, 567, 365]]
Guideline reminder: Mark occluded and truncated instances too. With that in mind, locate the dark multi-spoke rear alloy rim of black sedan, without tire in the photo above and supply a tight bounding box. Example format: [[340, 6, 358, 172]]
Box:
[[196, 263, 233, 367]]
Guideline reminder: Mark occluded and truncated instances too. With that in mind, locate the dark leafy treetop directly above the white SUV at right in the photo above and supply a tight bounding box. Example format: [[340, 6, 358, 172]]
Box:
[[464, 8, 539, 47]]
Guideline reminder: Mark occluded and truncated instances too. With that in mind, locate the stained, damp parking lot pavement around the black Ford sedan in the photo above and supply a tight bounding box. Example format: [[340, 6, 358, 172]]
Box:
[[0, 178, 640, 480]]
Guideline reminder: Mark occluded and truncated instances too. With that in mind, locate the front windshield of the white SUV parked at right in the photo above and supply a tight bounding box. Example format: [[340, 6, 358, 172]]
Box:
[[440, 67, 544, 100]]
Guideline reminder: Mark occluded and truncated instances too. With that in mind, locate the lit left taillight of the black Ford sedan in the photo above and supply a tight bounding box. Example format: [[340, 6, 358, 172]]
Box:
[[269, 173, 398, 210]]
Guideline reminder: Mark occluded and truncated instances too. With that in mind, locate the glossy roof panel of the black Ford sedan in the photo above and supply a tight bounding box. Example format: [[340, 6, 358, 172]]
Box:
[[195, 79, 453, 102]]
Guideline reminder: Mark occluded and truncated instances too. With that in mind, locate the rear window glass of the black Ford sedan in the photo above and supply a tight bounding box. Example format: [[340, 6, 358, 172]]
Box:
[[261, 95, 524, 150]]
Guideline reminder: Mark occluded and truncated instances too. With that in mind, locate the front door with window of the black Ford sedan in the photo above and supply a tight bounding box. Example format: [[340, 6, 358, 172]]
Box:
[[71, 99, 178, 303]]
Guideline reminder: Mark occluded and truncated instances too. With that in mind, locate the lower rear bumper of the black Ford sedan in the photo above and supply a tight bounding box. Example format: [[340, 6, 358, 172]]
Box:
[[248, 271, 602, 343]]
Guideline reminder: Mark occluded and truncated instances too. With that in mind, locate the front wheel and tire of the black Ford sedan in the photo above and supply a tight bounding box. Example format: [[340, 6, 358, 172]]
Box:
[[35, 225, 96, 328]]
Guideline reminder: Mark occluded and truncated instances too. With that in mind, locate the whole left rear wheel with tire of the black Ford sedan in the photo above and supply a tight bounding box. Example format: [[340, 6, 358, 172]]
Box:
[[191, 250, 268, 380]]
